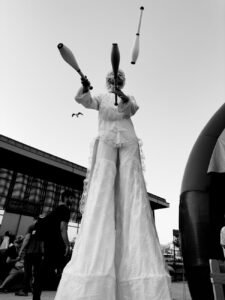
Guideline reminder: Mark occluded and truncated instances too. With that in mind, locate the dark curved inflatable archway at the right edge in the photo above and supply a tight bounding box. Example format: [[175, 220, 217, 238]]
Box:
[[179, 104, 225, 300]]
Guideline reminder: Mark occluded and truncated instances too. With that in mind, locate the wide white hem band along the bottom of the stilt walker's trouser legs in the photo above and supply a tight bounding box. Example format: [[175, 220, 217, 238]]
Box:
[[55, 272, 172, 300]]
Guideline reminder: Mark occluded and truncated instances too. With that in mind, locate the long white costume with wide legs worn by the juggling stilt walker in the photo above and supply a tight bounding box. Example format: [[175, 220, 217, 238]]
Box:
[[55, 89, 171, 300]]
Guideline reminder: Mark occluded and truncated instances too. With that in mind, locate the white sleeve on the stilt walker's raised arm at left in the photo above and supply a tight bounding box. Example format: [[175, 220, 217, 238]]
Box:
[[75, 87, 101, 110]]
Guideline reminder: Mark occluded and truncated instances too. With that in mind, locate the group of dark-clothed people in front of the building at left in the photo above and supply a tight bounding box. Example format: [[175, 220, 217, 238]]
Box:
[[0, 191, 73, 300]]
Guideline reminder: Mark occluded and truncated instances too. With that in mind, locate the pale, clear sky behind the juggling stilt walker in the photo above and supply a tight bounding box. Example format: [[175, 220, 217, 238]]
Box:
[[0, 0, 225, 244]]
